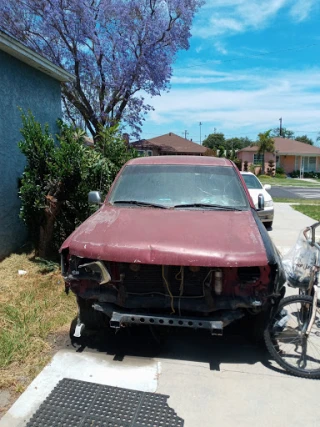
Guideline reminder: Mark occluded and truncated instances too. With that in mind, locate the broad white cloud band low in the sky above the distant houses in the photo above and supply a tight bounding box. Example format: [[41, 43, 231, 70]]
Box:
[[144, 69, 320, 140]]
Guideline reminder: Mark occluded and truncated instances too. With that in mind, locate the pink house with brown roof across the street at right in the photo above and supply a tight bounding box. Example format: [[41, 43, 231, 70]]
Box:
[[237, 138, 320, 174]]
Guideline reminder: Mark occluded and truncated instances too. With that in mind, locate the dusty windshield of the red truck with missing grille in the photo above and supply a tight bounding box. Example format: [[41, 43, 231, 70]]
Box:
[[109, 165, 248, 209]]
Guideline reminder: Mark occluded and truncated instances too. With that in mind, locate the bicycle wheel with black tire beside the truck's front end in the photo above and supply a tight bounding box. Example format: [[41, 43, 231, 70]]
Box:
[[264, 295, 320, 379]]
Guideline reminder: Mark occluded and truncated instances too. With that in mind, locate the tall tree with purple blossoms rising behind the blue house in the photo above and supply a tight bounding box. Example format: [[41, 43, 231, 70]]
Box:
[[0, 0, 204, 137]]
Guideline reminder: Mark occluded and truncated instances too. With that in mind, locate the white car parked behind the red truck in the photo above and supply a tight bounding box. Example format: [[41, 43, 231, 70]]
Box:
[[241, 172, 274, 227]]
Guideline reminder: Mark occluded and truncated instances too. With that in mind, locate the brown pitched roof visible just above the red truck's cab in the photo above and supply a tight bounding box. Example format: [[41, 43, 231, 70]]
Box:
[[131, 132, 207, 154]]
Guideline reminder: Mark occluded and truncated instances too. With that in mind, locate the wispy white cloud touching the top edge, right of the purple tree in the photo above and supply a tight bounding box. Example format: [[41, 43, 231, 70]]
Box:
[[192, 0, 317, 38]]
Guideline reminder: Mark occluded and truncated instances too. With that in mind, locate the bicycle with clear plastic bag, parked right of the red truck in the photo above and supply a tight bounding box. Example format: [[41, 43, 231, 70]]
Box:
[[264, 222, 320, 379]]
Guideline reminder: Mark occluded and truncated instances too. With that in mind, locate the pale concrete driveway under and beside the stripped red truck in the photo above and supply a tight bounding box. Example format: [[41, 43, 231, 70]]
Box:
[[0, 204, 320, 427]]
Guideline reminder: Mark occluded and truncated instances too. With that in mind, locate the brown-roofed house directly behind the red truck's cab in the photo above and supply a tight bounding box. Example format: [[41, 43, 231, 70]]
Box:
[[130, 132, 207, 156]]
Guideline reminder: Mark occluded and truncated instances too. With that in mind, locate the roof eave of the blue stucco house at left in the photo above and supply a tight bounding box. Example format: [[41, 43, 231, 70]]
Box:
[[0, 29, 74, 82]]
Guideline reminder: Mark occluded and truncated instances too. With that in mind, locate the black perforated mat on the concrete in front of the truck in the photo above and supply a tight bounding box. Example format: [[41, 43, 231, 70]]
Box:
[[26, 378, 184, 427]]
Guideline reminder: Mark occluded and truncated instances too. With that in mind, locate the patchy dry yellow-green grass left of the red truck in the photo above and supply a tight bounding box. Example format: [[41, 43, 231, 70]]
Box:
[[0, 253, 76, 394]]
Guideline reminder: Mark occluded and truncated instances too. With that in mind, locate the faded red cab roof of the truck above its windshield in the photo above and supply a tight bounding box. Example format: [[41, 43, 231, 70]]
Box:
[[127, 156, 233, 167]]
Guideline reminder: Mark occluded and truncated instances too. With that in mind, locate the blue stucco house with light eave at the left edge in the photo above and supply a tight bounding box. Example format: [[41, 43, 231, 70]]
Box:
[[0, 30, 73, 259]]
